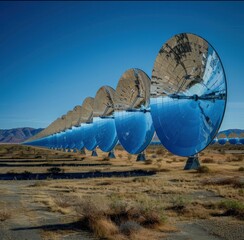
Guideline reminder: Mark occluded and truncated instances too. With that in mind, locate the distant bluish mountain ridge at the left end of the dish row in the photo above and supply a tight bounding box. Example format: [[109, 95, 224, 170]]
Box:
[[0, 127, 43, 143]]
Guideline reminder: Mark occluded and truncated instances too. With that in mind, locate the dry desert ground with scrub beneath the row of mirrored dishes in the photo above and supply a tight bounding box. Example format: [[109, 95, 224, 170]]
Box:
[[0, 144, 244, 240]]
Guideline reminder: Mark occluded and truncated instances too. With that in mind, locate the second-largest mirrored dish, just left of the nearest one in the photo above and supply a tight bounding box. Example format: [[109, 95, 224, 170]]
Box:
[[114, 69, 154, 154]]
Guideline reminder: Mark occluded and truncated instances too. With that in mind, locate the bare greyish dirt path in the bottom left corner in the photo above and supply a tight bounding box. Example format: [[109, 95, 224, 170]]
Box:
[[0, 181, 94, 240]]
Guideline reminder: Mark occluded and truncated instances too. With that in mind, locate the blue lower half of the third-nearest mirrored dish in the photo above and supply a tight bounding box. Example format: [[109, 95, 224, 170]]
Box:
[[93, 117, 118, 152]]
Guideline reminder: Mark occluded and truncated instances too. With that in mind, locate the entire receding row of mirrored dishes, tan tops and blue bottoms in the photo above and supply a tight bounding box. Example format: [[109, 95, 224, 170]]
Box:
[[25, 33, 227, 156]]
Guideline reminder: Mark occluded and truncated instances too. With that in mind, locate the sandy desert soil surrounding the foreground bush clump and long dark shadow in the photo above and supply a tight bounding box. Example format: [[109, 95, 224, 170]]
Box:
[[0, 145, 244, 240]]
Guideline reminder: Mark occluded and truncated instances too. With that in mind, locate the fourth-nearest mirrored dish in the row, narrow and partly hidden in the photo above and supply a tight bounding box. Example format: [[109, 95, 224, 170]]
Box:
[[81, 97, 97, 151]]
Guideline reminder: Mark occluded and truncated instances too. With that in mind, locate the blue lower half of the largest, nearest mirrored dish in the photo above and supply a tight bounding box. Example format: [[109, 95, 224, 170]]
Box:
[[151, 97, 225, 156]]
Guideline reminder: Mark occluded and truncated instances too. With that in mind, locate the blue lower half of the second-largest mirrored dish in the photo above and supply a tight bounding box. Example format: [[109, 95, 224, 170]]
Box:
[[115, 111, 154, 154]]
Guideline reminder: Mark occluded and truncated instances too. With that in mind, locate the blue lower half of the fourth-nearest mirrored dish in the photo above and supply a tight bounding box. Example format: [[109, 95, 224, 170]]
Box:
[[81, 123, 97, 151]]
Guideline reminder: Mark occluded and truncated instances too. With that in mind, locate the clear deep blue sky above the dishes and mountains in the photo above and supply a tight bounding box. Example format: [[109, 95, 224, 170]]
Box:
[[0, 1, 244, 129]]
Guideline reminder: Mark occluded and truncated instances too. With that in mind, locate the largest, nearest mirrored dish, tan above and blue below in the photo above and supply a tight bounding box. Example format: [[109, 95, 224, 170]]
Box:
[[150, 33, 227, 156]]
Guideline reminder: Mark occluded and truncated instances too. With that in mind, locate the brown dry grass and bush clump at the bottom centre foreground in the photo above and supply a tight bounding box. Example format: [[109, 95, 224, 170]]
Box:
[[76, 195, 165, 239]]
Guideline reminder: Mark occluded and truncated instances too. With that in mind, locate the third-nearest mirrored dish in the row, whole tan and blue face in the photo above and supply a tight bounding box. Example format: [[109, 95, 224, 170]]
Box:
[[93, 86, 118, 152]]
